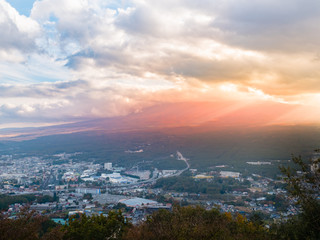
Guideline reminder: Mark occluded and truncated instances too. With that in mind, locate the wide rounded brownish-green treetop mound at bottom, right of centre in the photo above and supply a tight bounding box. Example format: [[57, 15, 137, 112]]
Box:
[[125, 206, 270, 240]]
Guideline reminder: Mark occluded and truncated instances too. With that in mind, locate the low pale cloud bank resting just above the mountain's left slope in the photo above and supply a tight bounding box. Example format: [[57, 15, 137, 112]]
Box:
[[0, 80, 164, 124]]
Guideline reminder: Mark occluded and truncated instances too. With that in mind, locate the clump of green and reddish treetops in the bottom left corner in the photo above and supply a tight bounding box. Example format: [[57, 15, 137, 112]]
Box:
[[0, 208, 131, 240]]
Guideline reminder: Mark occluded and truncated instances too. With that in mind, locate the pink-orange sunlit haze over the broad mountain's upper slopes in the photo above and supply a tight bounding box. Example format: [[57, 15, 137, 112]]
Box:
[[0, 101, 295, 140]]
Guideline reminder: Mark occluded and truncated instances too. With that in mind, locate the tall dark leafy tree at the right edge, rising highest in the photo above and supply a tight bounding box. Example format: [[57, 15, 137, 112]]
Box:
[[278, 149, 320, 239]]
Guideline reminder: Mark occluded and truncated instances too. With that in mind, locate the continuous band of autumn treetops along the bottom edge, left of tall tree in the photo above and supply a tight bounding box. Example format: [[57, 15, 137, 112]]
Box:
[[0, 207, 270, 240]]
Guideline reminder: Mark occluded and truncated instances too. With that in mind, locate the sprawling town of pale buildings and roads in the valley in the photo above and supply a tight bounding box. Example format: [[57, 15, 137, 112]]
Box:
[[0, 150, 298, 224]]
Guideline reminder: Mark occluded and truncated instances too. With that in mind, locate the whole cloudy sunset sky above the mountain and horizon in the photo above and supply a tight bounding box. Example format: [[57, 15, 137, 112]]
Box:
[[0, 0, 320, 128]]
